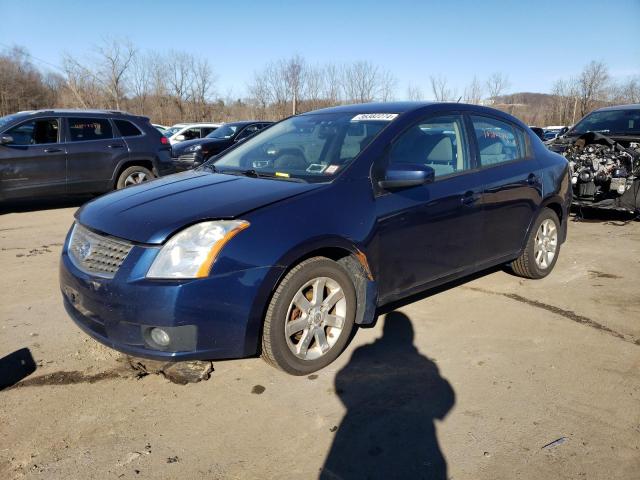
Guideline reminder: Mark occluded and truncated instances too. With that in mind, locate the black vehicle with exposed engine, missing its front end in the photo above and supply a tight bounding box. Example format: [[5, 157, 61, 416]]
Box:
[[547, 104, 640, 213]]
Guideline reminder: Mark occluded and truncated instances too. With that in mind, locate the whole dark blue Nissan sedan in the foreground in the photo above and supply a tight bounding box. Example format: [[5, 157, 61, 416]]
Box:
[[60, 103, 571, 375]]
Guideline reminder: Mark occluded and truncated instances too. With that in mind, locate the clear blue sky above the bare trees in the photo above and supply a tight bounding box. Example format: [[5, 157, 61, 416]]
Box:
[[0, 0, 640, 98]]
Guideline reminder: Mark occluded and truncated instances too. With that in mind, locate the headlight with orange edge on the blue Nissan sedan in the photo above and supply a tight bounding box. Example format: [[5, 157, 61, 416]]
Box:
[[147, 220, 249, 278]]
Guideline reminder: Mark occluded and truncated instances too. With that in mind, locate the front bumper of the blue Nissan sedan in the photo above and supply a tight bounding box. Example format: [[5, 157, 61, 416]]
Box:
[[60, 245, 277, 361]]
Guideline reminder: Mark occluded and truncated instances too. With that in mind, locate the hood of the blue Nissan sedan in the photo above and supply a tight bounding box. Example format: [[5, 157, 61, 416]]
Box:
[[76, 170, 322, 244]]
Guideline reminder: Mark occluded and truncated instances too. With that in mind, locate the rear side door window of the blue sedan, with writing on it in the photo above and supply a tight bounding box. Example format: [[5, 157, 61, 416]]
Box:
[[471, 115, 526, 167]]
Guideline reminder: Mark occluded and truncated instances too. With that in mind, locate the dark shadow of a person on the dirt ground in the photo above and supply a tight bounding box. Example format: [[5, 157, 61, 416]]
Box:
[[319, 312, 455, 480]]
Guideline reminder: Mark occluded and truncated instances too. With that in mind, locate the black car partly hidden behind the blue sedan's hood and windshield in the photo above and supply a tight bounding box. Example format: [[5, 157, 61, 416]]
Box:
[[172, 121, 273, 171]]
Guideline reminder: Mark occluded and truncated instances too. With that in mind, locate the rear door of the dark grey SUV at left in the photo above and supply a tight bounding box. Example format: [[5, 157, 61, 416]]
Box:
[[66, 117, 129, 193]]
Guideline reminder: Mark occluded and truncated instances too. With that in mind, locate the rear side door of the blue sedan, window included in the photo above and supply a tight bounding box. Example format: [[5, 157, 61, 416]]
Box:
[[469, 115, 542, 264]]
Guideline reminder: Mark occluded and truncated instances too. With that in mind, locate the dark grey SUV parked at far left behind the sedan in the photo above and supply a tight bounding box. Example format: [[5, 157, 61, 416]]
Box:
[[0, 110, 175, 201]]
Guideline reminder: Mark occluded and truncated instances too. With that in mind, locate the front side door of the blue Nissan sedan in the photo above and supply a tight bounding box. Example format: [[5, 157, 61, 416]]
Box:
[[374, 114, 482, 302]]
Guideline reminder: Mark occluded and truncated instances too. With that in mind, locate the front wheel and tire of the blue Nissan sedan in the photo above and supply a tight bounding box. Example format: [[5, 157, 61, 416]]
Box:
[[262, 257, 356, 375]]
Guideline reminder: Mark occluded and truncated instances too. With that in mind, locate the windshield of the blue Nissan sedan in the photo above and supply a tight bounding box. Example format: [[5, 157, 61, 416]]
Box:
[[204, 113, 397, 182]]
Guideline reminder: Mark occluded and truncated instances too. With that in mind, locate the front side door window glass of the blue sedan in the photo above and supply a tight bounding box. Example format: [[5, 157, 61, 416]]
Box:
[[389, 115, 471, 177]]
